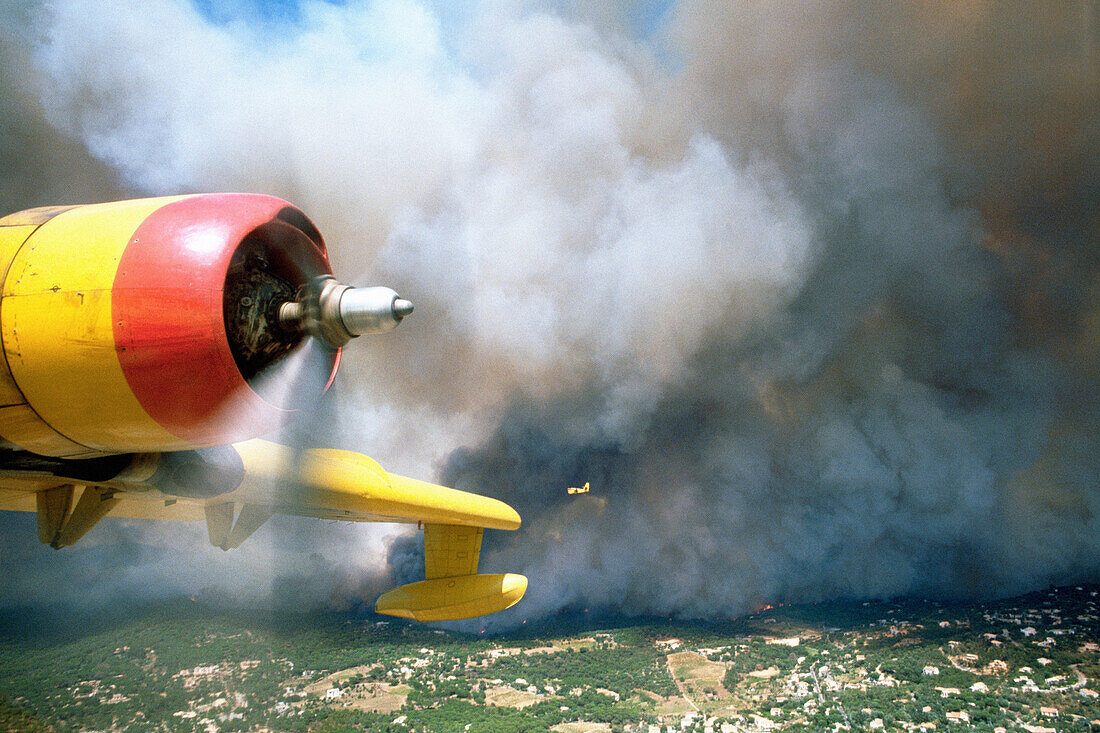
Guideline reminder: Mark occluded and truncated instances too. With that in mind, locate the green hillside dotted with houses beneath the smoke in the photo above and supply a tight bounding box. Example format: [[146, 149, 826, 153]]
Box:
[[0, 587, 1100, 733]]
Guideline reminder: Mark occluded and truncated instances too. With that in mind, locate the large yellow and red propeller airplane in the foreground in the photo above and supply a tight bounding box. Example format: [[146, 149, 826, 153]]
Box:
[[0, 194, 527, 622]]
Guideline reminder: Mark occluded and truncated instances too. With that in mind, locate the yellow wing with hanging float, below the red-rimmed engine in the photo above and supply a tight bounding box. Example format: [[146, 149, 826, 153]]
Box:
[[0, 440, 527, 621]]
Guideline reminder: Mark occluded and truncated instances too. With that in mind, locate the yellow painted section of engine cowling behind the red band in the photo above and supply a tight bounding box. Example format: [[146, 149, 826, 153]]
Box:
[[0, 197, 189, 456]]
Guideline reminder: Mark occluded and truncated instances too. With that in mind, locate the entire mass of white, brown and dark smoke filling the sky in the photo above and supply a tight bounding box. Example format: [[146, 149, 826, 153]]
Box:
[[0, 0, 1100, 624]]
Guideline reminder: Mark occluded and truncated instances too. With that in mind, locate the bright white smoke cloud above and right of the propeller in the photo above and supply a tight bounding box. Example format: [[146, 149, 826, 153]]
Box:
[[37, 0, 810, 429]]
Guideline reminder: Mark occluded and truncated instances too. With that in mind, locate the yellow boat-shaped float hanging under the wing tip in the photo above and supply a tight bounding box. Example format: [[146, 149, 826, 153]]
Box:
[[374, 572, 527, 622]]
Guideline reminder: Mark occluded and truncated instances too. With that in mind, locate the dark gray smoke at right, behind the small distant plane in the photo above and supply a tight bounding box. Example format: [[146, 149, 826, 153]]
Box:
[[389, 3, 1100, 624]]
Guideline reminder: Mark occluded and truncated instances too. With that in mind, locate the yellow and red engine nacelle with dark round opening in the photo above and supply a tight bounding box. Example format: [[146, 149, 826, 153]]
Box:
[[0, 194, 338, 458]]
